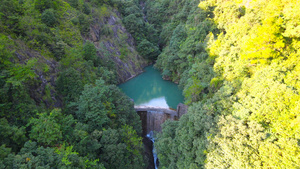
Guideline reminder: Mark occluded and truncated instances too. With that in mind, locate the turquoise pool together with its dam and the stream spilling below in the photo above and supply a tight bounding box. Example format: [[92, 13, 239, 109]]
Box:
[[119, 66, 187, 169]]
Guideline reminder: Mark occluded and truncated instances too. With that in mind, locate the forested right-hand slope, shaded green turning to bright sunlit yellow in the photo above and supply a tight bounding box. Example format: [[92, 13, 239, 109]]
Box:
[[147, 0, 300, 168]]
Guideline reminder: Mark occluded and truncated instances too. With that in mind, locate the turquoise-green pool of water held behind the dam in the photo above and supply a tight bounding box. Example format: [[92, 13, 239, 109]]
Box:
[[119, 66, 184, 109]]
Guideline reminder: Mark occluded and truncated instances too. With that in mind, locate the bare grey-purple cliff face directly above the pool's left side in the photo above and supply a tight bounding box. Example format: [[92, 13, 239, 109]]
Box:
[[84, 10, 149, 83]]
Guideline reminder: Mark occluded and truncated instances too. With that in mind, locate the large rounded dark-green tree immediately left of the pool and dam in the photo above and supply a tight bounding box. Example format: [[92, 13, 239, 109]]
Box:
[[76, 79, 141, 133]]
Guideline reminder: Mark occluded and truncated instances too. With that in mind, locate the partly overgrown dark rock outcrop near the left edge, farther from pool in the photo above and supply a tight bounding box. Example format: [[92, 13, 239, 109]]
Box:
[[11, 40, 62, 107]]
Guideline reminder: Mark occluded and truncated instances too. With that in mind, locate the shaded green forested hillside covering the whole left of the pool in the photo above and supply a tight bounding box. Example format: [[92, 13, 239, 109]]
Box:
[[0, 0, 146, 168]]
